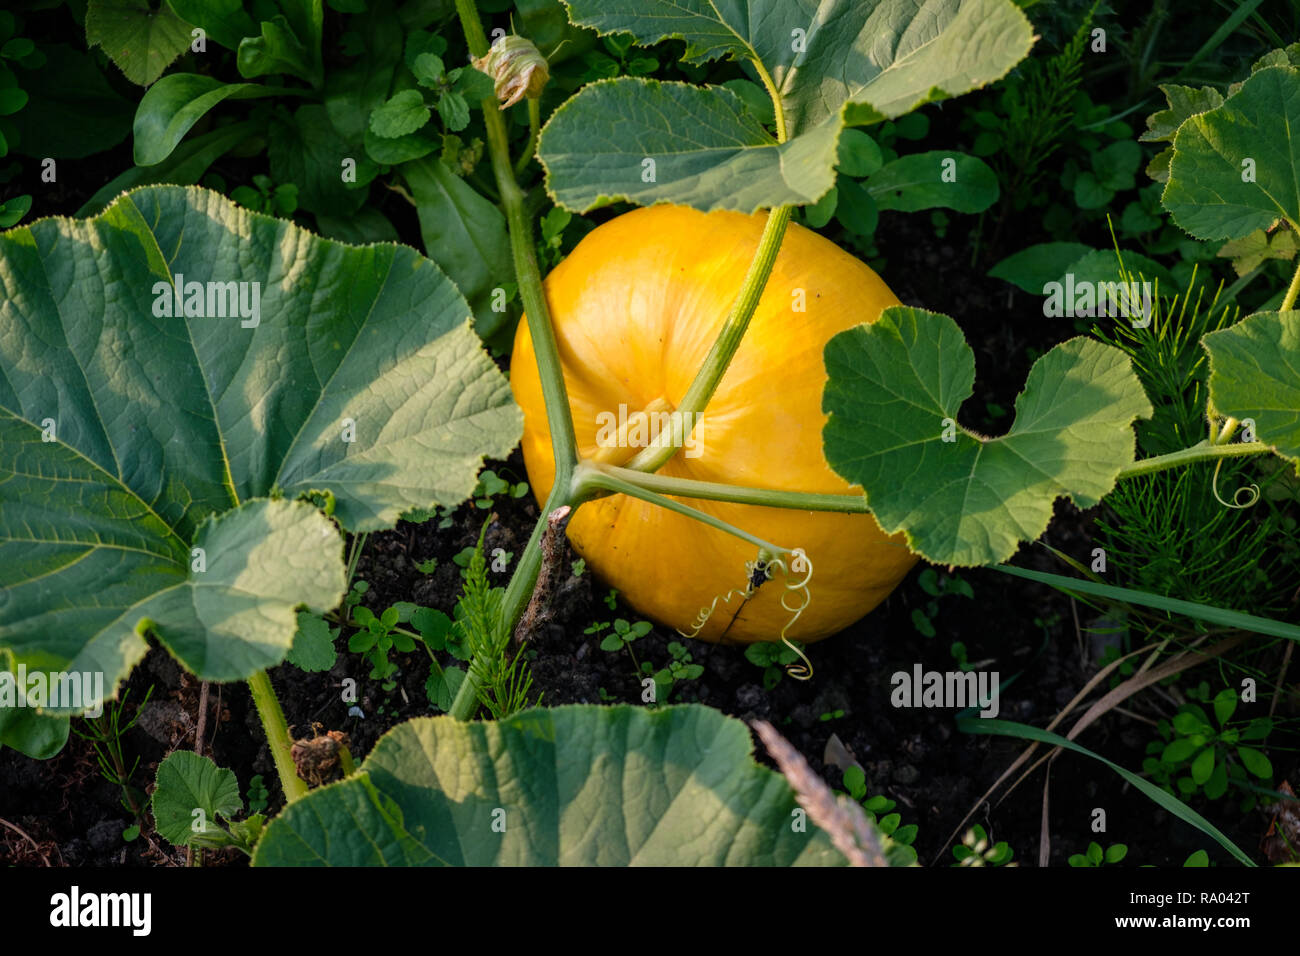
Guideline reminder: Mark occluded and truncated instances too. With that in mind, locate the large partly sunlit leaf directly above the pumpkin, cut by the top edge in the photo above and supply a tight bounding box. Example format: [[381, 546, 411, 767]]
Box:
[[538, 0, 1032, 212]]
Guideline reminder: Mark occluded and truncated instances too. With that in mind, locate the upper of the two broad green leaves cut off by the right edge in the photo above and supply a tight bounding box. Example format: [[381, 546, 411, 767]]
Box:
[[1162, 66, 1300, 239]]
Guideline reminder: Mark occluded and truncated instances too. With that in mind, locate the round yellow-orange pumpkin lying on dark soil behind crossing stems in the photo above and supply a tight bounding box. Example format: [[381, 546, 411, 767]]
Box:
[[511, 206, 915, 644]]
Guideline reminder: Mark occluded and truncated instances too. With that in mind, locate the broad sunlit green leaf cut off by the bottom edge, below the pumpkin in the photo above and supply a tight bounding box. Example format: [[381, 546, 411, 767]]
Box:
[[254, 705, 844, 866]]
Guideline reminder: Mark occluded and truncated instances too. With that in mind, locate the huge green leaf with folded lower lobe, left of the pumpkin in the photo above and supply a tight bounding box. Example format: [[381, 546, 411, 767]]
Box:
[[0, 186, 520, 689]]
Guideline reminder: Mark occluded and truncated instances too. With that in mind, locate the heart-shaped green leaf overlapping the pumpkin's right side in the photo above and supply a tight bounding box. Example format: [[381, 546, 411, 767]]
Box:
[[823, 307, 1151, 566]]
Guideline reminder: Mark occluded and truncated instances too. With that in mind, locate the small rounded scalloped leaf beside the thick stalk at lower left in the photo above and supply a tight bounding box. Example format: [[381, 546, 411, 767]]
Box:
[[151, 750, 243, 847]]
